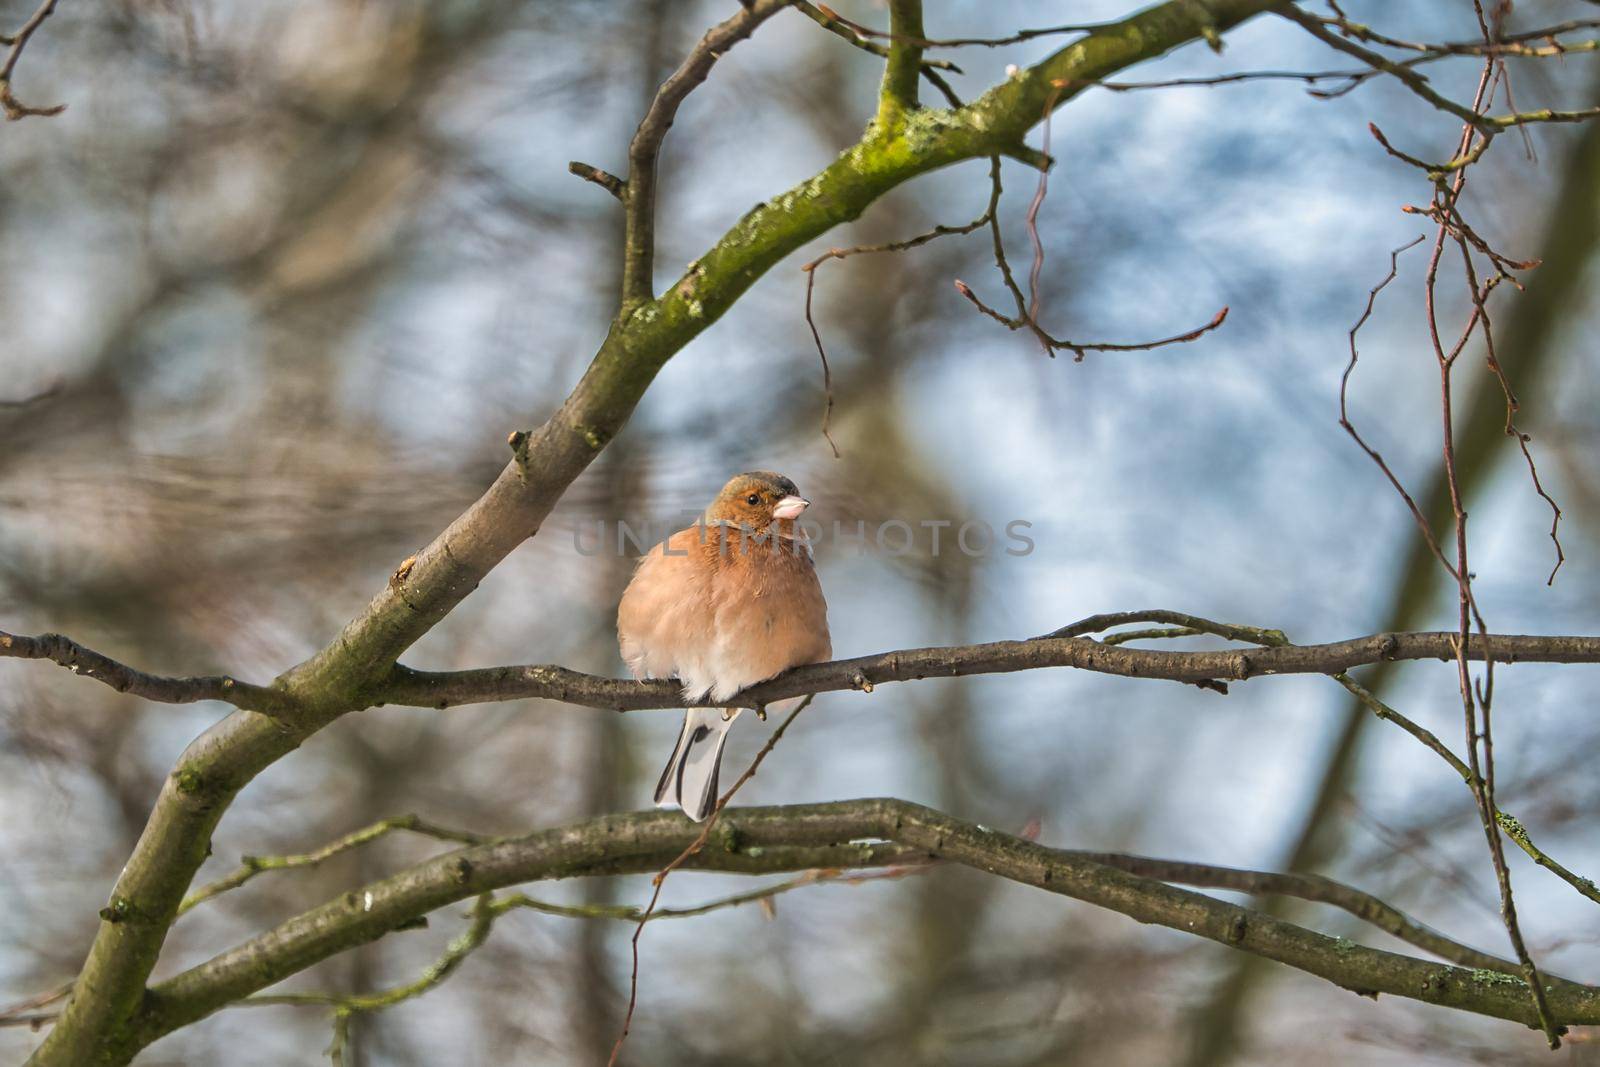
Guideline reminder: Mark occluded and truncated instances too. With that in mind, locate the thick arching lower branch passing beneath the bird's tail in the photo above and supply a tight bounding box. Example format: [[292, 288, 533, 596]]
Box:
[[134, 800, 1600, 1048]]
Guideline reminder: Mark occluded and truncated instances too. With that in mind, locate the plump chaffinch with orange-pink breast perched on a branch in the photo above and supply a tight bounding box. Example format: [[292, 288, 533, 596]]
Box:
[[616, 470, 834, 822]]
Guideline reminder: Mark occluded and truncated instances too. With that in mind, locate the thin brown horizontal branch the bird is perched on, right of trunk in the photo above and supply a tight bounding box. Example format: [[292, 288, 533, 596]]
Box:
[[371, 632, 1600, 712]]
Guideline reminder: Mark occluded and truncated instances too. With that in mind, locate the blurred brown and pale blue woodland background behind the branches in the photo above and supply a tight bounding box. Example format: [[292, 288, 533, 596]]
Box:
[[0, 0, 1600, 1065]]
